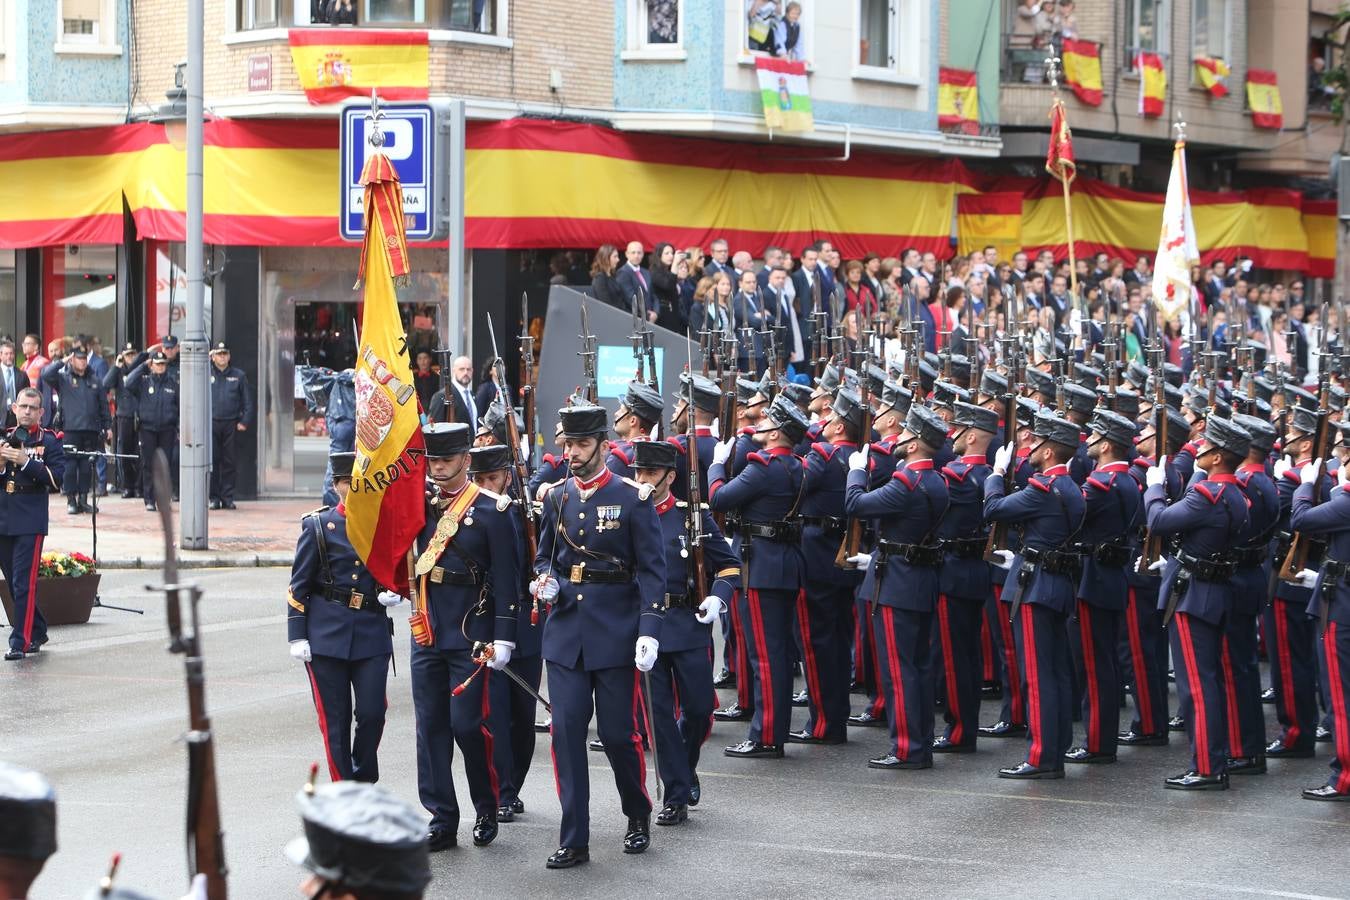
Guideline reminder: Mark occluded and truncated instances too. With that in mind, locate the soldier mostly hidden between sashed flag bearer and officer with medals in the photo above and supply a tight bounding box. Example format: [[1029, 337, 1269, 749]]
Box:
[[468, 444, 544, 822]]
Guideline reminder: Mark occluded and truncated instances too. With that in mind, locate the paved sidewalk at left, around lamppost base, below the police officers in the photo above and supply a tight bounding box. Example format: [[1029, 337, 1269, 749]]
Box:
[[43, 494, 320, 569]]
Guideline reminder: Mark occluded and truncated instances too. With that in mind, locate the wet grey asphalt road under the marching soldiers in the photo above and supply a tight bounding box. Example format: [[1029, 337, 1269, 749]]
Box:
[[0, 569, 1350, 900]]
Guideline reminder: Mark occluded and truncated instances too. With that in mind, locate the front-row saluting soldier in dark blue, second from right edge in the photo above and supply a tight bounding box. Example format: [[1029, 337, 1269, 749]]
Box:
[[1143, 416, 1251, 791]]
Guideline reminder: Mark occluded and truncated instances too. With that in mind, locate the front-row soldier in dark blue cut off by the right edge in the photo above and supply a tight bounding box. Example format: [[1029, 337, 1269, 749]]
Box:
[[1291, 450, 1350, 801]]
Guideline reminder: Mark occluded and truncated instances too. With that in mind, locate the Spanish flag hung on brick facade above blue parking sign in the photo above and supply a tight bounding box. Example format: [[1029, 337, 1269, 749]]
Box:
[[289, 28, 431, 105]]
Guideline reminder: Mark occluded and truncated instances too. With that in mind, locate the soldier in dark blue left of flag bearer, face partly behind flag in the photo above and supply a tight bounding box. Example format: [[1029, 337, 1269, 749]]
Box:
[[282, 453, 400, 781]]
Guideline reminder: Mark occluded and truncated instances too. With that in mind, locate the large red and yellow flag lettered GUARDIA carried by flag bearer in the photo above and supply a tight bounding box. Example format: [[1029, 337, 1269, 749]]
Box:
[[347, 152, 427, 595]]
